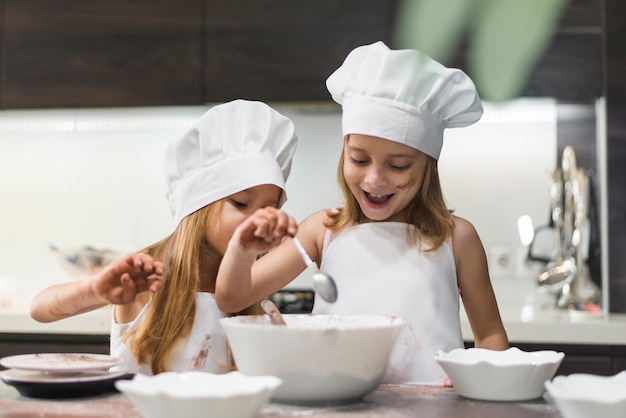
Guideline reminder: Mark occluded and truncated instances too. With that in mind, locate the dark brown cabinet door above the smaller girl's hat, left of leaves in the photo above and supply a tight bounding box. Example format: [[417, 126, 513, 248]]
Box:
[[201, 0, 396, 101]]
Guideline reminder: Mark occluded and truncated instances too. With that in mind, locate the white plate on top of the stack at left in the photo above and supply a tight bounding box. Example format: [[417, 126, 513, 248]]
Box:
[[0, 353, 124, 375]]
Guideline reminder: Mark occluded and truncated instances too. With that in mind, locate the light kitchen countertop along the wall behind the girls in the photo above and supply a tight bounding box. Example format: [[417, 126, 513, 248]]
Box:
[[0, 294, 626, 346]]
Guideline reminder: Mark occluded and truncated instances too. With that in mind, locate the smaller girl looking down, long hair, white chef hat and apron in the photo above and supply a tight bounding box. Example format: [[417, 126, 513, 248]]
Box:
[[31, 100, 297, 374]]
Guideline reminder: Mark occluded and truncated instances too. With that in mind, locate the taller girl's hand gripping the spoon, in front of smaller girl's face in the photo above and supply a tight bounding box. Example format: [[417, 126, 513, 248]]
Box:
[[231, 207, 298, 256]]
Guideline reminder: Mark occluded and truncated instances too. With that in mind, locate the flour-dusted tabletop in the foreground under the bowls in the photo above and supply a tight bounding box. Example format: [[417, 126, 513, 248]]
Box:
[[0, 382, 561, 418]]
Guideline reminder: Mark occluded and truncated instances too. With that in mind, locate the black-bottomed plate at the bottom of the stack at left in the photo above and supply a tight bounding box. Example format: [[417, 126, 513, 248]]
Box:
[[0, 369, 134, 399]]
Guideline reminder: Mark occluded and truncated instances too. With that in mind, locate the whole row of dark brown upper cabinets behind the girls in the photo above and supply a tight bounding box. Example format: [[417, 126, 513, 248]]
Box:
[[0, 0, 603, 109]]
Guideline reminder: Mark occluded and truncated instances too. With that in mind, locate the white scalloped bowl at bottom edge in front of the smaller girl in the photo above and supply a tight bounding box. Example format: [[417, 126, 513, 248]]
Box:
[[115, 371, 282, 418]]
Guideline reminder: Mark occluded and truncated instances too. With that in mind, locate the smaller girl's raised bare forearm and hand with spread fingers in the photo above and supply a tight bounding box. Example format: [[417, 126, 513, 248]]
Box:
[[30, 254, 163, 322]]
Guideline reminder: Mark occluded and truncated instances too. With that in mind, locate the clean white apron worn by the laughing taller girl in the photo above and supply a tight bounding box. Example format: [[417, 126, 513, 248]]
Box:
[[313, 222, 463, 385]]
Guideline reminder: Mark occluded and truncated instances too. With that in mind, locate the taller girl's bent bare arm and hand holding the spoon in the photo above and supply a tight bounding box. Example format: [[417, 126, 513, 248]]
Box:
[[215, 208, 319, 312]]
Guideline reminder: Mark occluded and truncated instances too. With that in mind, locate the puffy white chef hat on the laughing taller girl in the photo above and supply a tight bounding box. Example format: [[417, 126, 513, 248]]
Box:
[[326, 42, 483, 159]]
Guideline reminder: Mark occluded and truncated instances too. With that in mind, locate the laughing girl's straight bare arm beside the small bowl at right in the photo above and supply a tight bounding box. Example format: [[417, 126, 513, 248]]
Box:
[[453, 217, 509, 350]]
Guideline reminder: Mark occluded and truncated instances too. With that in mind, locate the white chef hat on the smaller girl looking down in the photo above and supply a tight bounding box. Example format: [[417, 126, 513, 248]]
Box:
[[165, 100, 297, 224]]
